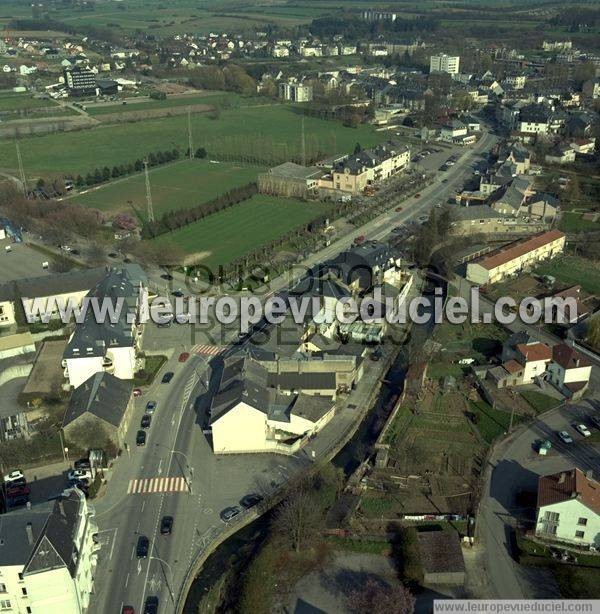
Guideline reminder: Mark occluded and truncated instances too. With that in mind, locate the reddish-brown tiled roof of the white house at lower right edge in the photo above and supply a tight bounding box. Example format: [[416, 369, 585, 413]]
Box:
[[537, 469, 600, 514]]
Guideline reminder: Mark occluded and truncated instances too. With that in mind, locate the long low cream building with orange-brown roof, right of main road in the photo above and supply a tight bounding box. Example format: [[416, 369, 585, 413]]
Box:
[[467, 230, 566, 286]]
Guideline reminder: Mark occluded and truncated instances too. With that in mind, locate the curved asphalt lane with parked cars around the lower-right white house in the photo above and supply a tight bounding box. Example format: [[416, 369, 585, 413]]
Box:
[[477, 402, 600, 599]]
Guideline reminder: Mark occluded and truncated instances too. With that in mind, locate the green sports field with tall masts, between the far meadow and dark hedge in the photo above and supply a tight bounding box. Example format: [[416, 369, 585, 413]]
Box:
[[69, 160, 262, 217]]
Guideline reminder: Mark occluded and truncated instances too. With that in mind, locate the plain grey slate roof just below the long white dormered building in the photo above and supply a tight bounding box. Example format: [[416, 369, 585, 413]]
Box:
[[63, 371, 133, 427]]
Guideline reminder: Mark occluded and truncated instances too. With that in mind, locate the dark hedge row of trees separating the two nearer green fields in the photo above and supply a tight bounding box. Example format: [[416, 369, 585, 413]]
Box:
[[142, 183, 258, 238]]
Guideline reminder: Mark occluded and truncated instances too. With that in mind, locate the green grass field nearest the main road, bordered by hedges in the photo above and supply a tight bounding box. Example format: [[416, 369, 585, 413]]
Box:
[[155, 195, 327, 268]]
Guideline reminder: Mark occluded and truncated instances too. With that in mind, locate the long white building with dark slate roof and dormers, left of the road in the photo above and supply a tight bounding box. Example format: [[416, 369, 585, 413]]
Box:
[[62, 265, 147, 388]]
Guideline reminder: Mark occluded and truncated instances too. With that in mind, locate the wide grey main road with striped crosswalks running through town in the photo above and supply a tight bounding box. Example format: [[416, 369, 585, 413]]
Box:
[[90, 127, 497, 614]]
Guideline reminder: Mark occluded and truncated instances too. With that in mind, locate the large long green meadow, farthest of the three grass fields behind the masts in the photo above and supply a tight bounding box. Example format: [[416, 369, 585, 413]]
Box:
[[0, 105, 387, 176]]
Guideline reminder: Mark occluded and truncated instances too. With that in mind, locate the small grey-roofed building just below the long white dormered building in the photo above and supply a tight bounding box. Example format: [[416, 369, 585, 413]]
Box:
[[62, 371, 134, 449]]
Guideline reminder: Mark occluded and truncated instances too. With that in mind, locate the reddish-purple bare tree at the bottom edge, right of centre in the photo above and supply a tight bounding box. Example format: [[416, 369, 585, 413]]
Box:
[[346, 578, 415, 614]]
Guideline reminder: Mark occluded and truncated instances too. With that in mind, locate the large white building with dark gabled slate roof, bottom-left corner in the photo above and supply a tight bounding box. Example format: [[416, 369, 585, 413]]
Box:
[[0, 488, 100, 614]]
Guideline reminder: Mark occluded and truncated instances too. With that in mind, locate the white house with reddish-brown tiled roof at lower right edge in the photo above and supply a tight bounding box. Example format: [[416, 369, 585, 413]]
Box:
[[535, 469, 600, 548]]
